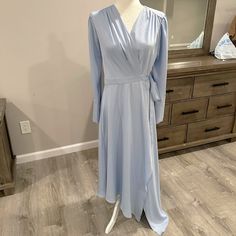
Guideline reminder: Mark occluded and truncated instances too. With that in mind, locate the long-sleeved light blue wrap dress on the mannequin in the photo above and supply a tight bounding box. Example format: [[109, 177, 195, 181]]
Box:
[[88, 4, 169, 234]]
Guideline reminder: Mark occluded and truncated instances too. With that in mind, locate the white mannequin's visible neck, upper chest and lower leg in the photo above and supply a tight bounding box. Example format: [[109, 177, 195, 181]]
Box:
[[105, 0, 147, 234]]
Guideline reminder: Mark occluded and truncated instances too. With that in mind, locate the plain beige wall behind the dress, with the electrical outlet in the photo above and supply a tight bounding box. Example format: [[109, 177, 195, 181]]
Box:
[[0, 0, 235, 155]]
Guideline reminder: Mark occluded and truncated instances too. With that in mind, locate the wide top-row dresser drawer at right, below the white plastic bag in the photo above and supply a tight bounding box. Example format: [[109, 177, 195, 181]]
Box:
[[193, 72, 236, 97]]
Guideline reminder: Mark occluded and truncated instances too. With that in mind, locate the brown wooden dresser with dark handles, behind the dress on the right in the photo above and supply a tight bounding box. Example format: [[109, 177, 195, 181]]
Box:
[[157, 56, 236, 154]]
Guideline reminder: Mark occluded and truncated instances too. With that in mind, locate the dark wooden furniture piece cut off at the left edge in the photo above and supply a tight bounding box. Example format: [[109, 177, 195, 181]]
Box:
[[0, 98, 15, 195]]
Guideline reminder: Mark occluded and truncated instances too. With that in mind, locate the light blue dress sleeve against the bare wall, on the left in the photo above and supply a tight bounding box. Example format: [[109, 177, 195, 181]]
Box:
[[88, 14, 102, 123]]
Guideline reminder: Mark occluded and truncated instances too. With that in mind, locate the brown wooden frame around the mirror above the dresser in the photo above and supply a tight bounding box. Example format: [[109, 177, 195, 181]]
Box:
[[168, 0, 217, 59]]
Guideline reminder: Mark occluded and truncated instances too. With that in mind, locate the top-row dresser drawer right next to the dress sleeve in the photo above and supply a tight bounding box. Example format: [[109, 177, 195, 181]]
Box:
[[166, 77, 193, 102]]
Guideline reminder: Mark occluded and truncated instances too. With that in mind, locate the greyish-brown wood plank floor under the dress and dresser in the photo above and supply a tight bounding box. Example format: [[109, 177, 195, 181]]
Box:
[[0, 142, 236, 236]]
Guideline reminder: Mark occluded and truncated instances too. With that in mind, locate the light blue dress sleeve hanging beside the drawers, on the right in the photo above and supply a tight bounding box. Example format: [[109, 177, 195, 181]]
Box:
[[151, 15, 168, 124]]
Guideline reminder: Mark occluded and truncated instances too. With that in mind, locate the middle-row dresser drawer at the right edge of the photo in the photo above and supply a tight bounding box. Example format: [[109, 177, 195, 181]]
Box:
[[207, 93, 236, 117]]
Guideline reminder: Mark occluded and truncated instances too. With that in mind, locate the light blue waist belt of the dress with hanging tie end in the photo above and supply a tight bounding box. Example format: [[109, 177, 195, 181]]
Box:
[[104, 74, 160, 101]]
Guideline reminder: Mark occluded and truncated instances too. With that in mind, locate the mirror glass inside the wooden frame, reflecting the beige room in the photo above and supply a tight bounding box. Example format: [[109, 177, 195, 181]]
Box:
[[142, 0, 208, 50]]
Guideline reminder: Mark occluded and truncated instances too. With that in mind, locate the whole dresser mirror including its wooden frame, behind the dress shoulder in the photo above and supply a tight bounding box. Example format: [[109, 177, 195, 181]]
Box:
[[140, 0, 216, 58]]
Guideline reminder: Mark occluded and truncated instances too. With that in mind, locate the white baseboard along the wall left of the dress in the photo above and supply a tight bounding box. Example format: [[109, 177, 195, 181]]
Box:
[[16, 140, 98, 164]]
